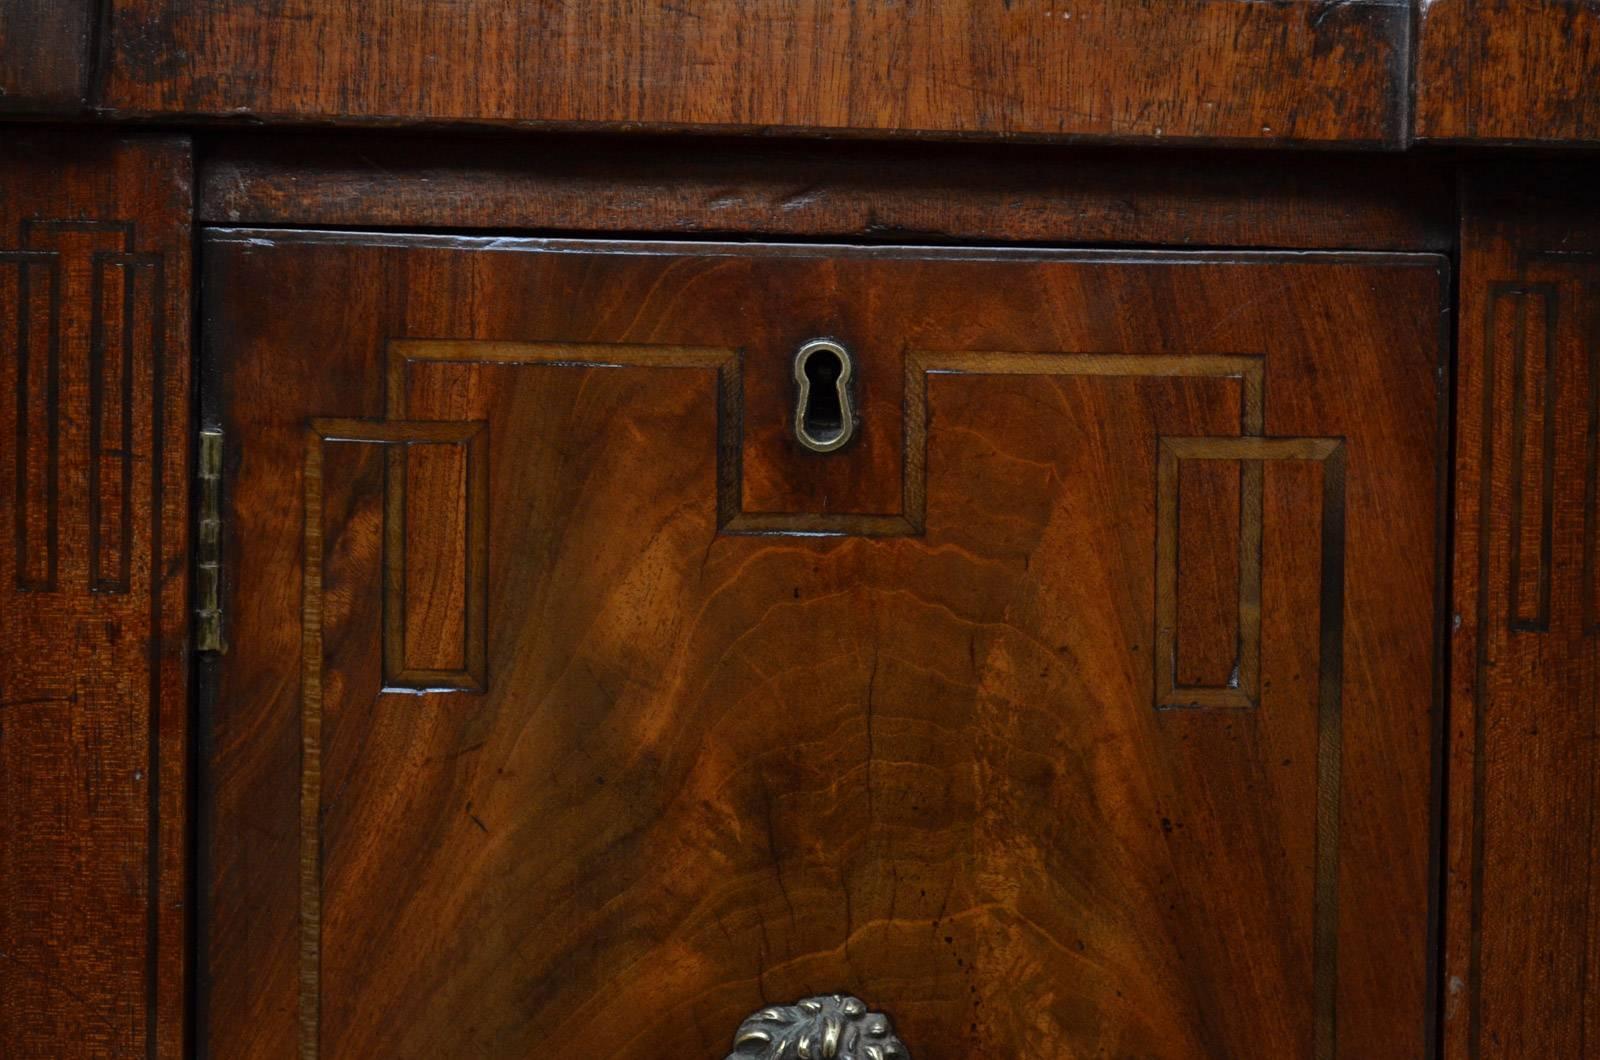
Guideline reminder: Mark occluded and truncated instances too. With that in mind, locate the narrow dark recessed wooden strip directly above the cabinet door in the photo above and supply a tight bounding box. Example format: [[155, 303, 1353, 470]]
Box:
[[198, 131, 1456, 250]]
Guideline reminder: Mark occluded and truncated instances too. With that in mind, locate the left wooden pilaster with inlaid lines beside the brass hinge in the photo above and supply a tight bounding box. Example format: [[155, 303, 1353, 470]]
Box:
[[0, 131, 190, 1058]]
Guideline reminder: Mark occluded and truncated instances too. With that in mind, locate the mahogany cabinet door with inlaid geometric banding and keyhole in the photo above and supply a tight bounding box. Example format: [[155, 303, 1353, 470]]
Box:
[[200, 231, 1446, 1060]]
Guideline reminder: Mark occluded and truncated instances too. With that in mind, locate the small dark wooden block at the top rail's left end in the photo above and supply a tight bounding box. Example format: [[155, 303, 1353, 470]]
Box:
[[0, 0, 98, 114]]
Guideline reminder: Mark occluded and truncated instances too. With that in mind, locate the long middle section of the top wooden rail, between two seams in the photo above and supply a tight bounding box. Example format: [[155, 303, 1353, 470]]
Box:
[[106, 0, 1411, 146]]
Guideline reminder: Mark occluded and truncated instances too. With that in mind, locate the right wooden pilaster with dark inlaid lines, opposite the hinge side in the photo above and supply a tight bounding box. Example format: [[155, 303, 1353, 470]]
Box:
[[1445, 168, 1600, 1060]]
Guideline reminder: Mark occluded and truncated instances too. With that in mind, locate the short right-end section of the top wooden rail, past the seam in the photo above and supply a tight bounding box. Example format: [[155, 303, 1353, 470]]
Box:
[[1414, 0, 1600, 144]]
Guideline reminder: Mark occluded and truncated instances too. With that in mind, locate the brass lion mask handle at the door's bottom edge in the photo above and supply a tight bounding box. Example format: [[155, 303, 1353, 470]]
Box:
[[728, 994, 910, 1060]]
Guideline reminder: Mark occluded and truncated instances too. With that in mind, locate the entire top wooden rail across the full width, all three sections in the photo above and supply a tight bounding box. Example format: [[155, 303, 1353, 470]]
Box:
[[0, 0, 1600, 149]]
